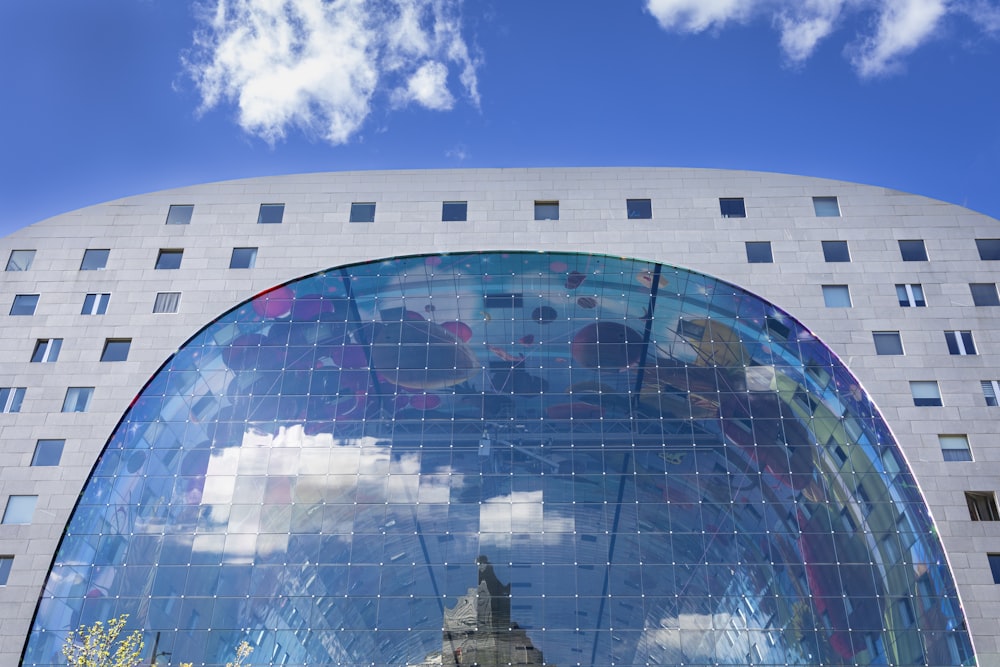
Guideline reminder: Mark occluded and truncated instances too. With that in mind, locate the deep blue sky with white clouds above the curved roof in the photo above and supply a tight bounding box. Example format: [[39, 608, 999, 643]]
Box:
[[0, 0, 1000, 234]]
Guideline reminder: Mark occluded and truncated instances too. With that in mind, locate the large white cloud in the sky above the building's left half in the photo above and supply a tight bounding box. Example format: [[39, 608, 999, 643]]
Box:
[[185, 0, 479, 144]]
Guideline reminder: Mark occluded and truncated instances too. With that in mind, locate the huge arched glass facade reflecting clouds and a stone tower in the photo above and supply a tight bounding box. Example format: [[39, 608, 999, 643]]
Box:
[[24, 253, 974, 667]]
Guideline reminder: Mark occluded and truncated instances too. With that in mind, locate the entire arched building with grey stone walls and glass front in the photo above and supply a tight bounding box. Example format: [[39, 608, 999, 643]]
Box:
[[0, 168, 1000, 667]]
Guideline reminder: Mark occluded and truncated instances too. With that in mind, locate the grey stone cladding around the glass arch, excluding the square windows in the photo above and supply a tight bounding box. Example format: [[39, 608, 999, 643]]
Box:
[[0, 168, 1000, 667]]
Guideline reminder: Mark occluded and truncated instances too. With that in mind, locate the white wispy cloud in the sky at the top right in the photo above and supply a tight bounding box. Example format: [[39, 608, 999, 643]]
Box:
[[646, 0, 1000, 78]]
